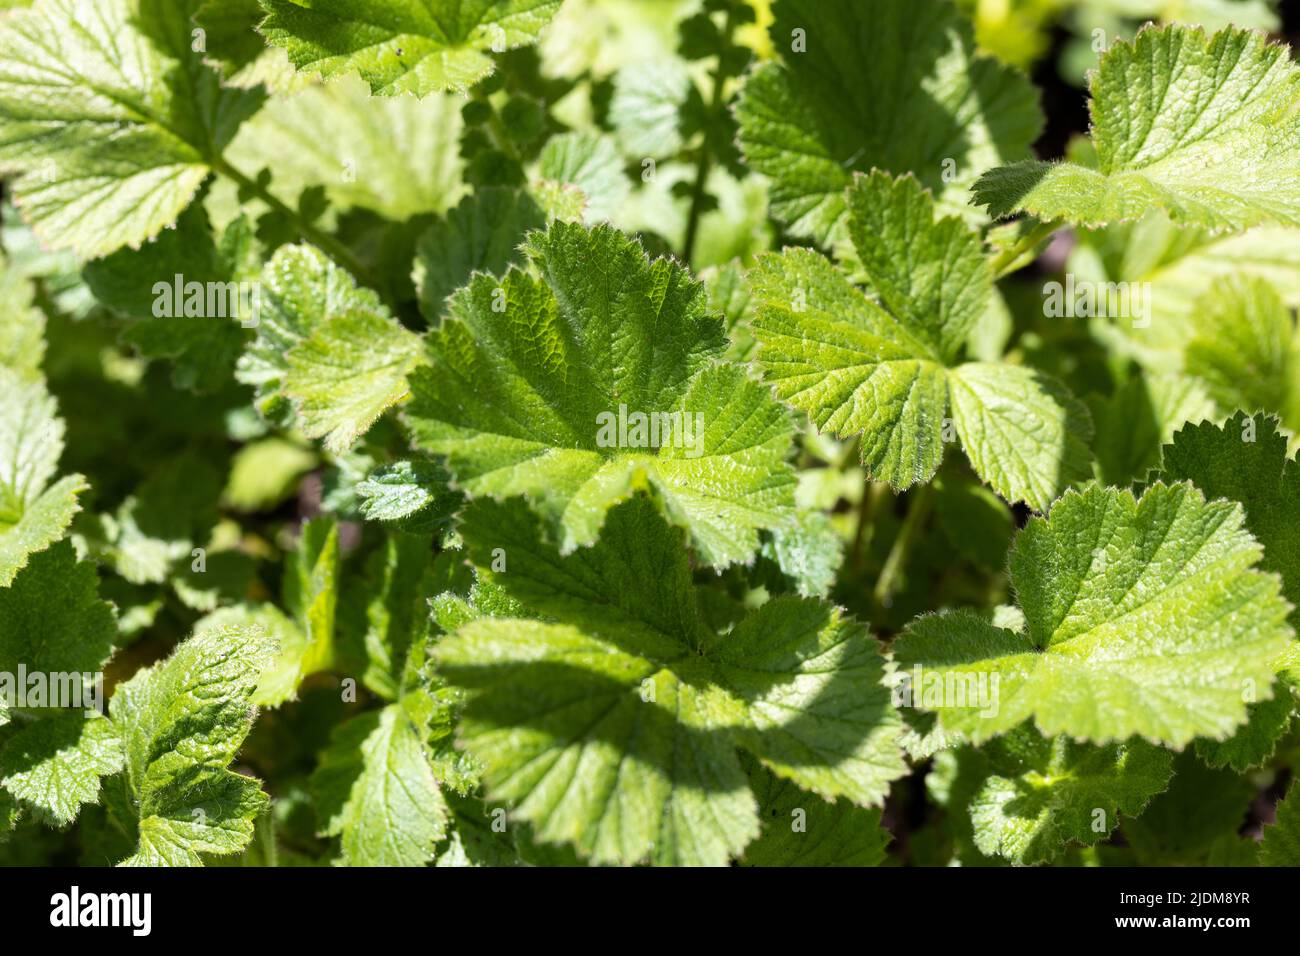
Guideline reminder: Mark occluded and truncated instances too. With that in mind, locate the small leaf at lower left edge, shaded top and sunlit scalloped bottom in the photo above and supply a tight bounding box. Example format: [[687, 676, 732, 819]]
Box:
[[0, 710, 124, 827]]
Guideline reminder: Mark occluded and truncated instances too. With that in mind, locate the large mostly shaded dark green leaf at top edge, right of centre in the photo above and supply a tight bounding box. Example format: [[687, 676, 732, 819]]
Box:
[[736, 0, 1041, 245]]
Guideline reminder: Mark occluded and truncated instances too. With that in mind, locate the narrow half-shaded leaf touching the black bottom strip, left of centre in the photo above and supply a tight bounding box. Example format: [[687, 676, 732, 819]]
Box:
[[312, 692, 447, 866]]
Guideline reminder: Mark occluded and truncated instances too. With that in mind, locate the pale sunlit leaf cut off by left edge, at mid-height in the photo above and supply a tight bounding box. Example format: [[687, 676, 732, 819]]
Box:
[[0, 368, 87, 588]]
